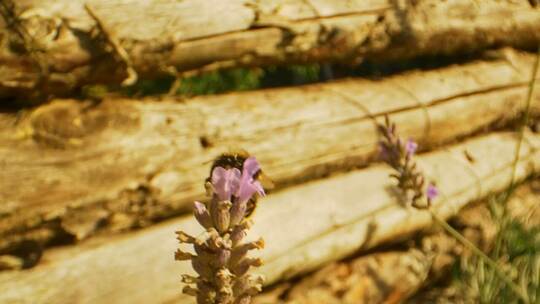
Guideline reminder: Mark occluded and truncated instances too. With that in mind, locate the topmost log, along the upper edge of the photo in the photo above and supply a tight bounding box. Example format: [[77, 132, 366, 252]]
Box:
[[0, 0, 540, 97]]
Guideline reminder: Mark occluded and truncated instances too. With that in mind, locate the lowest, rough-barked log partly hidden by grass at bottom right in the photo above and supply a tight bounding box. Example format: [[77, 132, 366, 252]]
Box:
[[254, 184, 540, 304]]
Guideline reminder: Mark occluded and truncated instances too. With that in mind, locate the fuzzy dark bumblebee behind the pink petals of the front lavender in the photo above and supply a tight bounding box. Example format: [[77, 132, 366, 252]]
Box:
[[206, 149, 274, 218]]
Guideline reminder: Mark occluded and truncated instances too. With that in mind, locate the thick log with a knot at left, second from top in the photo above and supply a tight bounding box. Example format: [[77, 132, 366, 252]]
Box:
[[0, 53, 540, 253]]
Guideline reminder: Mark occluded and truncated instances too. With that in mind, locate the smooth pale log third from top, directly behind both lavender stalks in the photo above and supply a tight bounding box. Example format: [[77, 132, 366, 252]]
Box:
[[0, 133, 540, 304]]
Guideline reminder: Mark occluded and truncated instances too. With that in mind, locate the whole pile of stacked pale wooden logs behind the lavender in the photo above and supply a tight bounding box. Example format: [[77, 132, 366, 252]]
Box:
[[0, 0, 540, 304]]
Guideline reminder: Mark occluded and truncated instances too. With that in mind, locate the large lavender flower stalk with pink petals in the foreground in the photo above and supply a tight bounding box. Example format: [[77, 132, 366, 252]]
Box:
[[175, 157, 265, 304]]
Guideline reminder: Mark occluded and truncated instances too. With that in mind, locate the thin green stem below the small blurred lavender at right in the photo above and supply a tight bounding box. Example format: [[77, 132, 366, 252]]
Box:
[[429, 209, 529, 303]]
